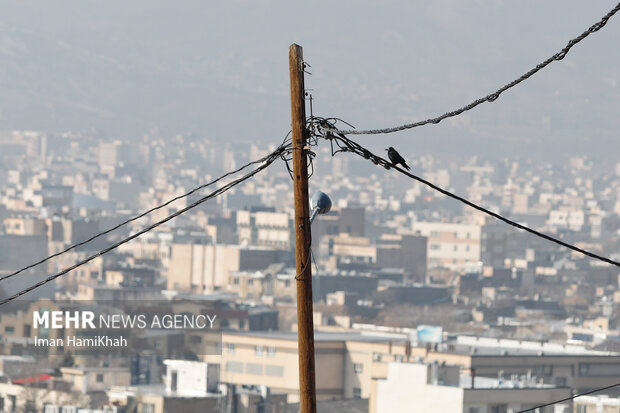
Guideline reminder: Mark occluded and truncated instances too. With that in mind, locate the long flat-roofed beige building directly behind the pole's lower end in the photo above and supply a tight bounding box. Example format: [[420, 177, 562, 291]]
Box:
[[205, 331, 412, 402]]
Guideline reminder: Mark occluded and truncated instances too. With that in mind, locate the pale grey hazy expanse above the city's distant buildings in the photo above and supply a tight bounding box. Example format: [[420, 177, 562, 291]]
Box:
[[0, 0, 620, 157]]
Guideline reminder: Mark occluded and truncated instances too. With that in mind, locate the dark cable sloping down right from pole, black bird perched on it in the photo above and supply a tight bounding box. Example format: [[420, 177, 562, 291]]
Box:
[[325, 130, 620, 267]]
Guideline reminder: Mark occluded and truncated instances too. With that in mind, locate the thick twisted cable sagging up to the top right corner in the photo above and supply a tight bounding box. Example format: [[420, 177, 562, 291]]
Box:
[[341, 3, 620, 135]]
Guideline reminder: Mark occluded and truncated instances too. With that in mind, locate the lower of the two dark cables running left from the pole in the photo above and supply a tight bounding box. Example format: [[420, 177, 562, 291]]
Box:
[[0, 144, 290, 306]]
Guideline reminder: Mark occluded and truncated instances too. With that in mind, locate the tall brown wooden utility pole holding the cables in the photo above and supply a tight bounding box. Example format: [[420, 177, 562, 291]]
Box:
[[289, 44, 316, 413]]
